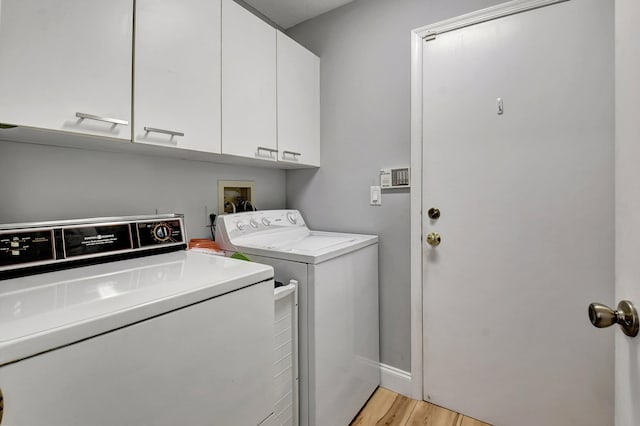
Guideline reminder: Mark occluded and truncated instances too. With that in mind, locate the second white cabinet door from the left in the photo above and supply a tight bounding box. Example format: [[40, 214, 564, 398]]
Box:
[[134, 0, 221, 153]]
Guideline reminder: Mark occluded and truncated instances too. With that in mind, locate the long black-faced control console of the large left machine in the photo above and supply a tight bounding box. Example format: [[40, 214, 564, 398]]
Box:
[[0, 215, 186, 279]]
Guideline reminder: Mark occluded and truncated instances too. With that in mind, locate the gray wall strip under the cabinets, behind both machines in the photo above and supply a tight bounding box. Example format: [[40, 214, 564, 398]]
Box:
[[0, 141, 285, 238]]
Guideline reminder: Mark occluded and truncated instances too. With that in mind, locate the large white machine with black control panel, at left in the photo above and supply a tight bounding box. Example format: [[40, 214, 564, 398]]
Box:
[[0, 215, 274, 426]]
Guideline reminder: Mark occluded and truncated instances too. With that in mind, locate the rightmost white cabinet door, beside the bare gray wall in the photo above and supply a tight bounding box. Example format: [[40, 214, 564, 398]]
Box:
[[278, 31, 320, 166]]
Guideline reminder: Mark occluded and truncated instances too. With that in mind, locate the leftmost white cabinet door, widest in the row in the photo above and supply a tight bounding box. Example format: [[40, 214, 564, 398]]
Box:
[[0, 0, 133, 140]]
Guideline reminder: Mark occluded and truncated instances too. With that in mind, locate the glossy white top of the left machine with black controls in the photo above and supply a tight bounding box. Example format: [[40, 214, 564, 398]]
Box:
[[0, 251, 273, 366]]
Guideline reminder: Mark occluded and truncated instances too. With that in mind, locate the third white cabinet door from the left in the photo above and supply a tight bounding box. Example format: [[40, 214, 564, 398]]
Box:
[[222, 0, 277, 161]]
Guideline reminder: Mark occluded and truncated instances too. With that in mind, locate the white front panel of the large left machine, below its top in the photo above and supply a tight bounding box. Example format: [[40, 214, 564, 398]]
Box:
[[0, 281, 274, 426]]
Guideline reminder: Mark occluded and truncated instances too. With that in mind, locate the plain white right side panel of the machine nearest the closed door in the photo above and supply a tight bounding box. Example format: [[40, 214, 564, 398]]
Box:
[[309, 244, 380, 426]]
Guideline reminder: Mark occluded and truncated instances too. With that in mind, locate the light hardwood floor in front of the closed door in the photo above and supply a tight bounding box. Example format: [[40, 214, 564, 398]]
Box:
[[351, 388, 491, 426]]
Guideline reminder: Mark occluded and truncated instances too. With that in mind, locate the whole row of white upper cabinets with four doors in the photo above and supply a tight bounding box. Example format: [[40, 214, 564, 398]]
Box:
[[0, 0, 320, 168]]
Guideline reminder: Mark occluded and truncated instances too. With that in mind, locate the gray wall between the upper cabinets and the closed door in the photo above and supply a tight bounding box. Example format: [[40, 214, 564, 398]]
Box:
[[287, 0, 501, 371]]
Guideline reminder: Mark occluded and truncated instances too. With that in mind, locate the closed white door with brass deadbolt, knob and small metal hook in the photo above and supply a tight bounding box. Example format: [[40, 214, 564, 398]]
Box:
[[422, 0, 614, 426]]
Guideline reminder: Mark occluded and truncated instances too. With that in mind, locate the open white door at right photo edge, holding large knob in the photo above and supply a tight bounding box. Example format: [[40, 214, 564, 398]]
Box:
[[612, 0, 640, 426]]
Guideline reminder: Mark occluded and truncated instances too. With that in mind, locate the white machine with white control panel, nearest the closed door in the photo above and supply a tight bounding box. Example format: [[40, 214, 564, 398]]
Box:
[[216, 210, 380, 426]]
